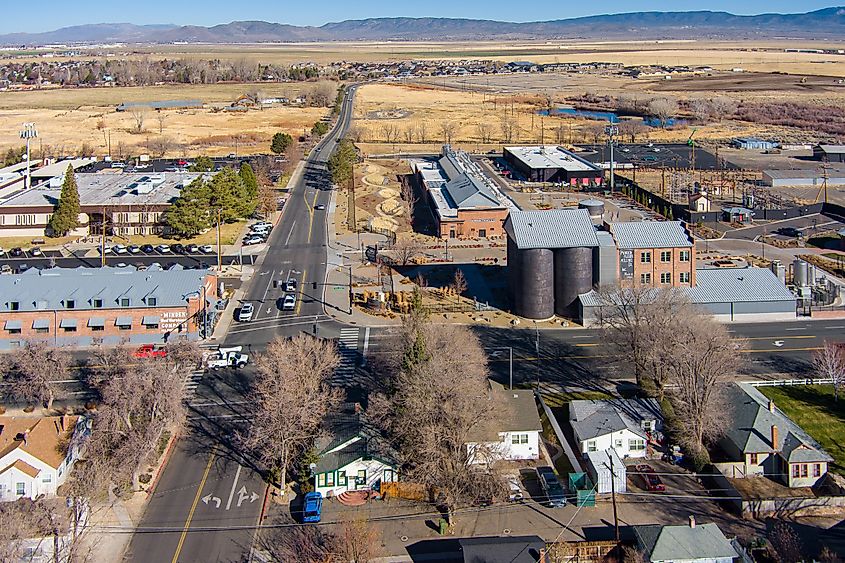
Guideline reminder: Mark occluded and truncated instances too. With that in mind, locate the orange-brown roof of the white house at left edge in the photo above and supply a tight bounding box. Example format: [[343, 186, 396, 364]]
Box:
[[0, 416, 79, 469]]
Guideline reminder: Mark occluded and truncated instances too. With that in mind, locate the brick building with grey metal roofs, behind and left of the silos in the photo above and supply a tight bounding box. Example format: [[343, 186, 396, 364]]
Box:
[[414, 145, 516, 239]]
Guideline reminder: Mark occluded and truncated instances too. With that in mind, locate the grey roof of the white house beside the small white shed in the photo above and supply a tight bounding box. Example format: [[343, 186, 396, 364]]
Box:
[[569, 399, 663, 440]]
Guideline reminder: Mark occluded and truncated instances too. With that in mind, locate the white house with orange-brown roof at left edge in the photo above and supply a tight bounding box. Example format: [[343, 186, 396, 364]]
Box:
[[0, 416, 90, 502]]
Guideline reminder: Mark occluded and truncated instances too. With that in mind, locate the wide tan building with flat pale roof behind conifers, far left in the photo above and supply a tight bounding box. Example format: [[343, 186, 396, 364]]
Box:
[[0, 168, 202, 237]]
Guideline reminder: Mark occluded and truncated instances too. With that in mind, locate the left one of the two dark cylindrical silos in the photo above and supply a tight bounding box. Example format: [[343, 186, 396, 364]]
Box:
[[514, 248, 555, 320]]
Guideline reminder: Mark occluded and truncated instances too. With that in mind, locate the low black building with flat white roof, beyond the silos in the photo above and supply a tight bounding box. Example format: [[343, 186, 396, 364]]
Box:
[[503, 145, 604, 188]]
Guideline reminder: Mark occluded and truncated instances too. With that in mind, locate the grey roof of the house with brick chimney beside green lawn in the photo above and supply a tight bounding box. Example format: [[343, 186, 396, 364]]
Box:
[[725, 383, 833, 463]]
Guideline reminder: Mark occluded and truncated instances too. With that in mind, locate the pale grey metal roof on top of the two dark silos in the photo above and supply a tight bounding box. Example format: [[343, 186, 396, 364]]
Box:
[[504, 209, 599, 249]]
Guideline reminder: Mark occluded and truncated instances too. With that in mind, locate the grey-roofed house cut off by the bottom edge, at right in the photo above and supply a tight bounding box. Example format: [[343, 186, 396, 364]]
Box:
[[634, 516, 739, 563]]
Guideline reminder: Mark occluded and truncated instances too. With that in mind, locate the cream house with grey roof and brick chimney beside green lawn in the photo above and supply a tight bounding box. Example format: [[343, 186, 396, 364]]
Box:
[[719, 383, 833, 488]]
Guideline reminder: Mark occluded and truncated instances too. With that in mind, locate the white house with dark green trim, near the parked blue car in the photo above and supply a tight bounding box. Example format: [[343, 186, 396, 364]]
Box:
[[314, 405, 399, 497]]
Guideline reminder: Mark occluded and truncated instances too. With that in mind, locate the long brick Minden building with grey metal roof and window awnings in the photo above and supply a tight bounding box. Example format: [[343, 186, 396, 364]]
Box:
[[0, 266, 217, 349]]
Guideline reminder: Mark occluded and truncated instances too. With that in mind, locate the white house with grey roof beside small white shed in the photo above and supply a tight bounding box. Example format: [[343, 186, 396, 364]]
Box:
[[569, 399, 663, 459]]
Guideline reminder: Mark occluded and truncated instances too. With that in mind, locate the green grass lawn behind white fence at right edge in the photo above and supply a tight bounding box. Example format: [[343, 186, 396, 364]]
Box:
[[758, 385, 845, 475]]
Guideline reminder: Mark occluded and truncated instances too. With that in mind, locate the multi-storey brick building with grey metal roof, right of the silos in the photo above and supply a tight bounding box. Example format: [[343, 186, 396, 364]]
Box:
[[605, 221, 695, 287]]
